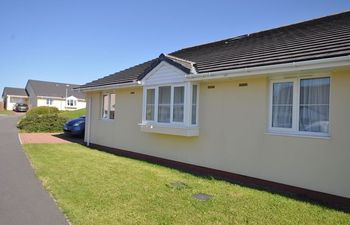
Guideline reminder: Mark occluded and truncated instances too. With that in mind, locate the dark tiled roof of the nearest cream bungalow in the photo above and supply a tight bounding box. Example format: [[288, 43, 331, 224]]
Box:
[[80, 11, 350, 88]]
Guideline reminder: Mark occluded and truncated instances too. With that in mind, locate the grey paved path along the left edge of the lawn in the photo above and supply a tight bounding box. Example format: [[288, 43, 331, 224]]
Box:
[[0, 116, 68, 225]]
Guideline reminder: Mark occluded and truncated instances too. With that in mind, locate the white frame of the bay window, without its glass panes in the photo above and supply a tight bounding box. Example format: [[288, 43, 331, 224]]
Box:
[[142, 82, 199, 127]]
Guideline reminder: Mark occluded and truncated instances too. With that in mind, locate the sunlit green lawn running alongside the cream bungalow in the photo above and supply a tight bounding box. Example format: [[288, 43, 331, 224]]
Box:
[[24, 144, 350, 225]]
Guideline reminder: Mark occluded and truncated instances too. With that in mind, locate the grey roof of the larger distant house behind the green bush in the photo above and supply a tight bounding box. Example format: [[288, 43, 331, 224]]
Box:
[[27, 80, 85, 99]]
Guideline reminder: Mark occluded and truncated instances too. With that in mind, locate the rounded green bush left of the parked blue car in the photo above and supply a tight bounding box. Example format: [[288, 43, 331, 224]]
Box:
[[18, 113, 67, 132]]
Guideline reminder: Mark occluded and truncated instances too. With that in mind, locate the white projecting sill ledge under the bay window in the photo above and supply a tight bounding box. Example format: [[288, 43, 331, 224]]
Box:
[[139, 124, 199, 137]]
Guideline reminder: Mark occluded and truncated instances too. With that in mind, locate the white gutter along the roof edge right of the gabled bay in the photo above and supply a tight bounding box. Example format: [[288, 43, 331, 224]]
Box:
[[185, 55, 350, 81]]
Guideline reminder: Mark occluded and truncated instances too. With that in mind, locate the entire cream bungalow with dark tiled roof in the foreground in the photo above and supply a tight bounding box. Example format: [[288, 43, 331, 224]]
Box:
[[79, 12, 350, 205]]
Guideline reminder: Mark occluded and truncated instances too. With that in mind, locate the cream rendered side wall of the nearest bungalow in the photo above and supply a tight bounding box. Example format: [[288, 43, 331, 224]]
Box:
[[88, 69, 350, 197]]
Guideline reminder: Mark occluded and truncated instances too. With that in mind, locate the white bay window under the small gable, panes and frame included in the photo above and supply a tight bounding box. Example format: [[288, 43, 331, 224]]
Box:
[[141, 83, 198, 136]]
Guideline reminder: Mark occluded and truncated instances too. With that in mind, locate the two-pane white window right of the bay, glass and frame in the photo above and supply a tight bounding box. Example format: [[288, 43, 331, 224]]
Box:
[[270, 77, 330, 135]]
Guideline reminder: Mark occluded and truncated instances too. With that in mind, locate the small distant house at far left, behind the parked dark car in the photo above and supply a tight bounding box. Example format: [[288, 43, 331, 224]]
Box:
[[2, 87, 28, 110]]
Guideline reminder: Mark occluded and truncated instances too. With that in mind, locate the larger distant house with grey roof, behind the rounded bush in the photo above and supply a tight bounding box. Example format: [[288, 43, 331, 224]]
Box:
[[25, 80, 86, 110]]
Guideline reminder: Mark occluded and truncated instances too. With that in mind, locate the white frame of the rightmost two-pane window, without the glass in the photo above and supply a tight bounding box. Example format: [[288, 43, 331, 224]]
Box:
[[268, 75, 332, 137]]
